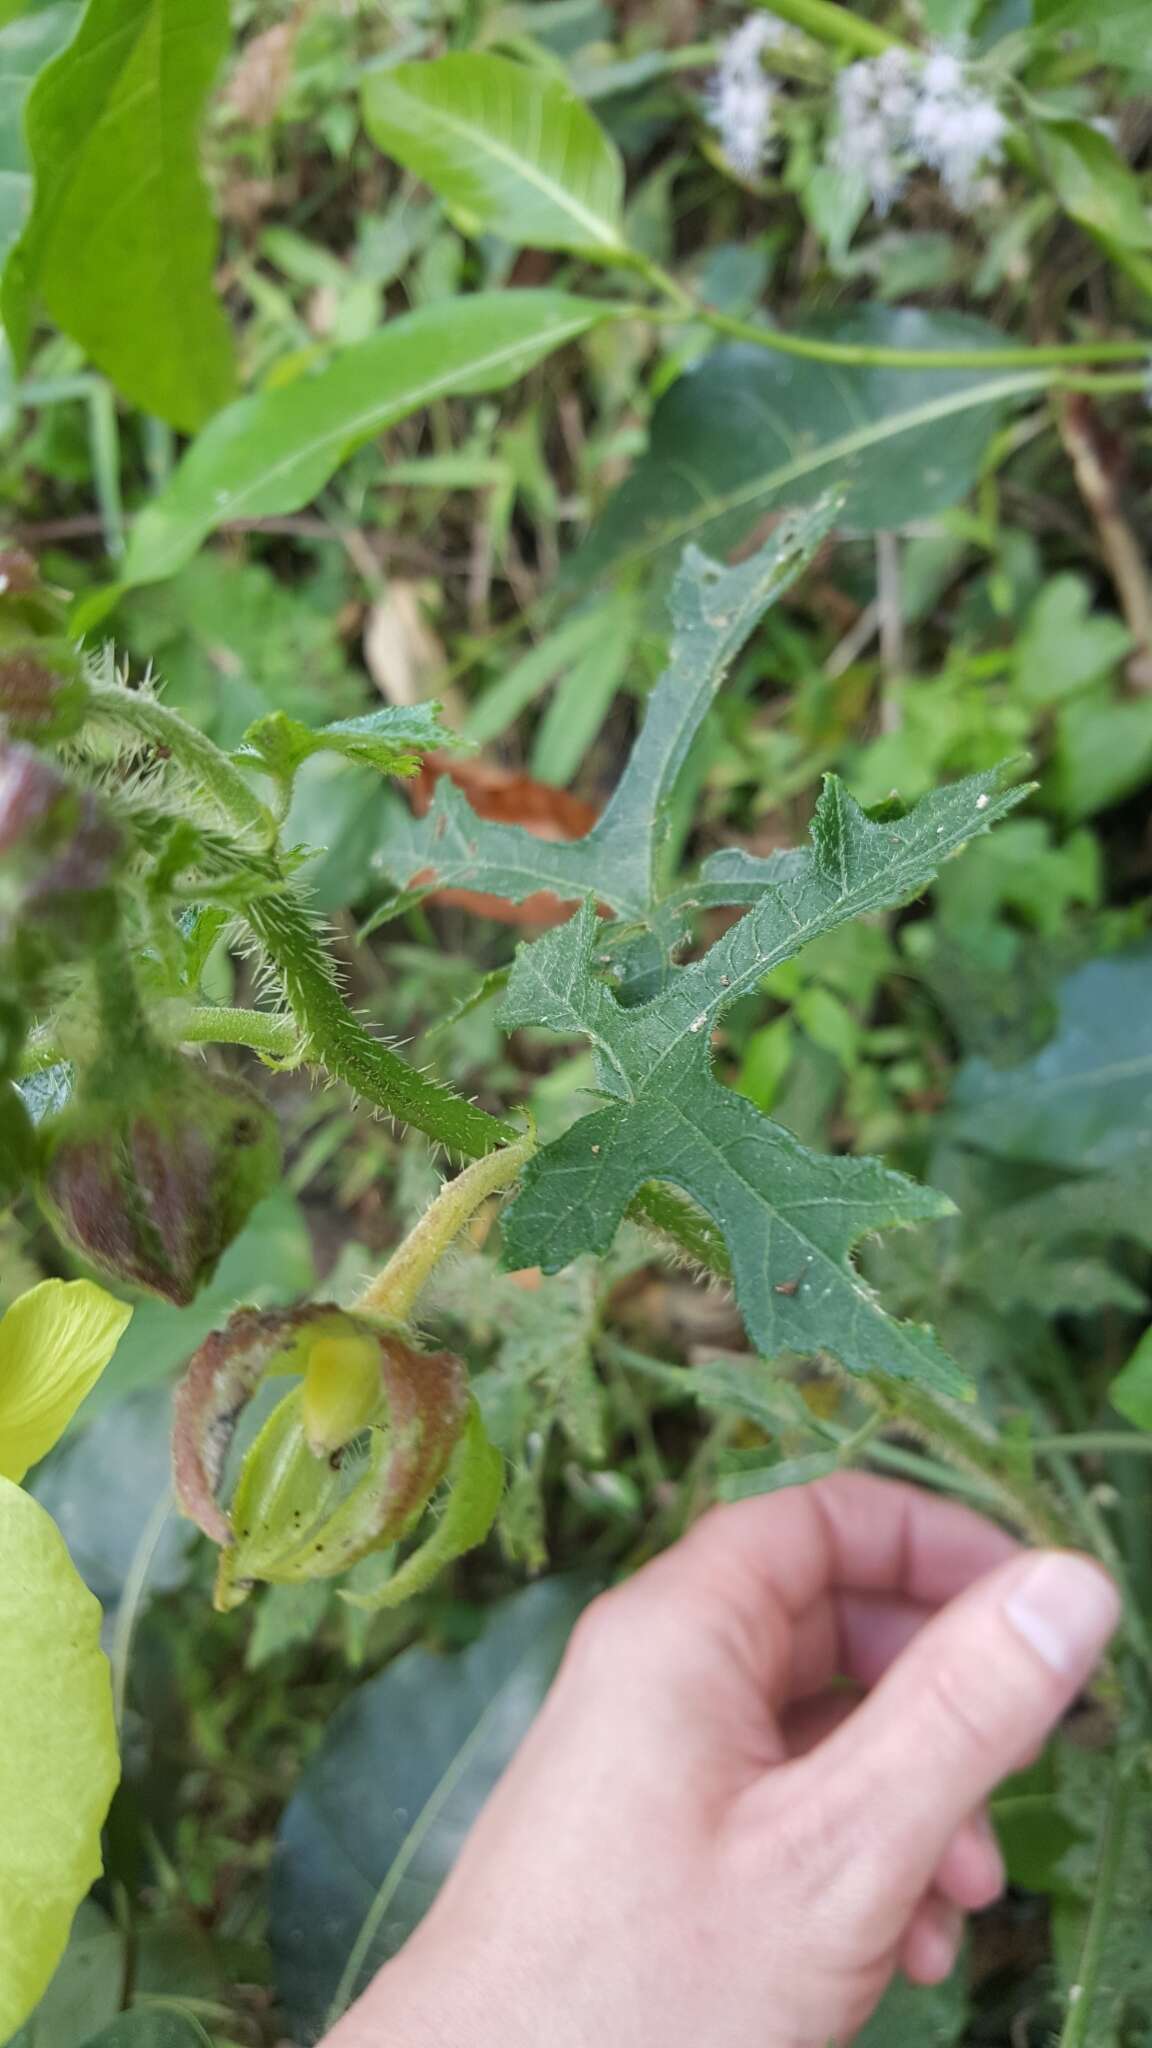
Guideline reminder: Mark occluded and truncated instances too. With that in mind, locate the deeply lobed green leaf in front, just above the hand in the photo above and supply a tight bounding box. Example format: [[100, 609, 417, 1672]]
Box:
[[502, 774, 1021, 1391]]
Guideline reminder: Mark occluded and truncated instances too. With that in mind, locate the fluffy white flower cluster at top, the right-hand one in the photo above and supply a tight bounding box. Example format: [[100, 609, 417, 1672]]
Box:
[[832, 49, 1009, 213]]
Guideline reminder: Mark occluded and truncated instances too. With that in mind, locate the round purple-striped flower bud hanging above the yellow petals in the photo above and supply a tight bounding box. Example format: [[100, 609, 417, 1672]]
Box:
[[41, 1051, 281, 1307]]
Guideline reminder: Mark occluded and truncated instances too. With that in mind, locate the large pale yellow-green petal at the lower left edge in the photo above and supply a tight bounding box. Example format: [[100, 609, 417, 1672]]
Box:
[[0, 1479, 119, 2040]]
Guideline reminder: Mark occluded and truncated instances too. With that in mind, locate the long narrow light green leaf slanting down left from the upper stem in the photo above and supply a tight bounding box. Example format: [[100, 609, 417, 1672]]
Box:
[[123, 291, 609, 584]]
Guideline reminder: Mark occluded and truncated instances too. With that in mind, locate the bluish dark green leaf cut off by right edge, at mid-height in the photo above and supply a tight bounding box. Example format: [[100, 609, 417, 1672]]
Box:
[[949, 946, 1152, 1174]]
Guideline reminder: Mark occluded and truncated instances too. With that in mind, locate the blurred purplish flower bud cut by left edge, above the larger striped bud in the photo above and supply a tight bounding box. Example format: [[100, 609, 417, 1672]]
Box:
[[0, 741, 123, 946]]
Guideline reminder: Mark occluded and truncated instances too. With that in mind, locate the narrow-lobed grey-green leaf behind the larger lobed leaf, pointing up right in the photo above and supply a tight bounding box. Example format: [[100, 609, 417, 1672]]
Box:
[[373, 498, 836, 920]]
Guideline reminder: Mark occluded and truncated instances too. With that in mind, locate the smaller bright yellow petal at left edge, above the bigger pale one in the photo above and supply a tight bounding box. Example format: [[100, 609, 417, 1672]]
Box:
[[0, 1280, 131, 1481]]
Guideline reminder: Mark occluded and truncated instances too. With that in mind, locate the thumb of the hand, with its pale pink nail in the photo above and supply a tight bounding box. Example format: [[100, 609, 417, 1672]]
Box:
[[793, 1550, 1121, 1937]]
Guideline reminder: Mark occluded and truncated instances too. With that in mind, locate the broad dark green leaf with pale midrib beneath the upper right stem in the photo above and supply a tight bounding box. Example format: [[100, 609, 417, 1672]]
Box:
[[572, 305, 1045, 582]]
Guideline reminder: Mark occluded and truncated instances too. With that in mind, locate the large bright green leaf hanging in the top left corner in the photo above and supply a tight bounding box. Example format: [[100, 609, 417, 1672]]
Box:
[[4, 0, 234, 428]]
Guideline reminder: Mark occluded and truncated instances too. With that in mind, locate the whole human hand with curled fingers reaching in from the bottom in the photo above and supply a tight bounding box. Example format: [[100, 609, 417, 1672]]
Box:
[[326, 1473, 1119, 2048]]
